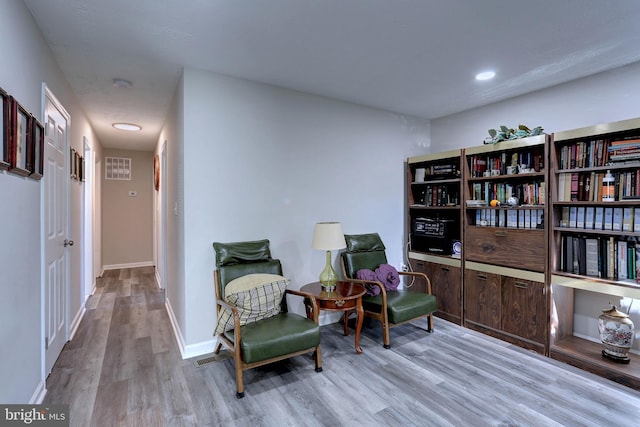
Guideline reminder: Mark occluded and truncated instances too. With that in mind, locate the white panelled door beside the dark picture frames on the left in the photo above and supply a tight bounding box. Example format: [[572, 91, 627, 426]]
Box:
[[42, 87, 72, 376]]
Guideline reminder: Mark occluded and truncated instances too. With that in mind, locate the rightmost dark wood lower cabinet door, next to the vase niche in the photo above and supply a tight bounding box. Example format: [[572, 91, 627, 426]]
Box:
[[502, 276, 547, 343]]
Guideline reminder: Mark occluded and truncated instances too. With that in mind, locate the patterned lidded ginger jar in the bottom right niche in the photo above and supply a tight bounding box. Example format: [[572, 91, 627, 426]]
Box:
[[598, 305, 635, 363]]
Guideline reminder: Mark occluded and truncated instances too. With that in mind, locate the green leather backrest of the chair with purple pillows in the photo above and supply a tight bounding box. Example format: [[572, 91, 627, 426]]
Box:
[[342, 233, 387, 279]]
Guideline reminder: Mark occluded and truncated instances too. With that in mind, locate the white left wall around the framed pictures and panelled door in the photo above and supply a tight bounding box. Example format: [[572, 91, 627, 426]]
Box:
[[0, 0, 99, 403]]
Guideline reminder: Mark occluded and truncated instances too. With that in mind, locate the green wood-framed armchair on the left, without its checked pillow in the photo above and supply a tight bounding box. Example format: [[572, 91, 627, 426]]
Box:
[[213, 239, 322, 398]]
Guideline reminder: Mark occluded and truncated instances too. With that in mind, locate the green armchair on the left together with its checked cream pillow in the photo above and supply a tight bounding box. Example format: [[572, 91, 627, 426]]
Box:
[[213, 240, 322, 398]]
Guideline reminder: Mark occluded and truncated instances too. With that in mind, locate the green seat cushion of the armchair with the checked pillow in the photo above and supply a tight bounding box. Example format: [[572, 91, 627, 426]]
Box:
[[224, 313, 320, 363]]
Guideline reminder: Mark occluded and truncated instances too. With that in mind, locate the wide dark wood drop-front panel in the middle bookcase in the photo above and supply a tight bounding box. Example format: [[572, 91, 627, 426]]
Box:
[[464, 227, 545, 271]]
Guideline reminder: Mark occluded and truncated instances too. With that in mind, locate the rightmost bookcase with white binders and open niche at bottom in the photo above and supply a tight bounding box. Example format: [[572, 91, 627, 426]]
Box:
[[549, 119, 640, 389]]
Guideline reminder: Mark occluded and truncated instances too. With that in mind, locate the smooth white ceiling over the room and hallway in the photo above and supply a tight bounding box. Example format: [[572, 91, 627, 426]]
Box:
[[24, 0, 640, 150]]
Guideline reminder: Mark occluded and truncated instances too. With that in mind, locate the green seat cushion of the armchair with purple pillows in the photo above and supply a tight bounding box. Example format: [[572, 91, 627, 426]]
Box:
[[362, 290, 437, 323]]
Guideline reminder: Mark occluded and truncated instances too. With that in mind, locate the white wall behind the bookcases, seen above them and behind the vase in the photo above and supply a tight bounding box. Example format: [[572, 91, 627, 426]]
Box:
[[431, 63, 640, 351]]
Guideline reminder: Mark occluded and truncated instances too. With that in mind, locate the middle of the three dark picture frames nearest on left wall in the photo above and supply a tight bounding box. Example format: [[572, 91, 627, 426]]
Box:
[[9, 97, 33, 176]]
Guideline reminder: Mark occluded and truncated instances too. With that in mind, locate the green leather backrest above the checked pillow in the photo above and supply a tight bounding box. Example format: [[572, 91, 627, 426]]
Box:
[[213, 239, 282, 298]]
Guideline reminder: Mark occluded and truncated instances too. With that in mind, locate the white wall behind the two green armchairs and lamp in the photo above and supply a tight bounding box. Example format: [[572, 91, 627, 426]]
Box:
[[164, 69, 429, 355]]
